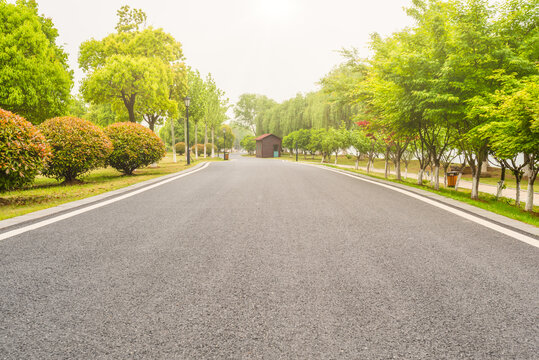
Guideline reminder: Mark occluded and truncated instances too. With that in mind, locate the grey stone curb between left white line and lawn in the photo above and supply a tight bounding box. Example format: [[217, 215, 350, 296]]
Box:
[[0, 161, 207, 231]]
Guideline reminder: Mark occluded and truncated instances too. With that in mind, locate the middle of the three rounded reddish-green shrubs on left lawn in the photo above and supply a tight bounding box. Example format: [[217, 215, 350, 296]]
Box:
[[39, 116, 112, 183]]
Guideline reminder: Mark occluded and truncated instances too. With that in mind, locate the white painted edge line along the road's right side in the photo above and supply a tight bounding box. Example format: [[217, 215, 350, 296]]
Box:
[[302, 164, 539, 248]]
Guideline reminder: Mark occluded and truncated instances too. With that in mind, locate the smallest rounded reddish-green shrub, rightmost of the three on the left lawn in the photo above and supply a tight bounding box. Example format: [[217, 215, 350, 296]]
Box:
[[105, 122, 165, 175]]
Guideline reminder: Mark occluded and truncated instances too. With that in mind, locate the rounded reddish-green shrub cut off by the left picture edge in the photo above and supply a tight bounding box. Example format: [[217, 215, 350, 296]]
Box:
[[0, 109, 51, 191]]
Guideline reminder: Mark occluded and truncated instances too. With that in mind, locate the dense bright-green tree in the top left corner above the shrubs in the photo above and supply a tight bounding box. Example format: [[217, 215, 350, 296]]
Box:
[[0, 0, 73, 124]]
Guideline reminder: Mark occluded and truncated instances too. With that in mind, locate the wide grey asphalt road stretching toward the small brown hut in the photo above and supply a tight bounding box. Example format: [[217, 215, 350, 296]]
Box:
[[0, 158, 539, 359]]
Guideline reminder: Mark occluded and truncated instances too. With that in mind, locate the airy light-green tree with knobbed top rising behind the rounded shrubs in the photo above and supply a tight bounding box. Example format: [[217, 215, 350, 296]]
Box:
[[79, 6, 183, 128]]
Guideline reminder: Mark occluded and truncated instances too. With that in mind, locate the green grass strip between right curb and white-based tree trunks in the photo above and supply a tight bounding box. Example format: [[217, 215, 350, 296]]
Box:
[[326, 164, 539, 226]]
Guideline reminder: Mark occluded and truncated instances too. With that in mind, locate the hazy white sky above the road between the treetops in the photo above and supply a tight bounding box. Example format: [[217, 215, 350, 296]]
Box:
[[32, 0, 412, 108]]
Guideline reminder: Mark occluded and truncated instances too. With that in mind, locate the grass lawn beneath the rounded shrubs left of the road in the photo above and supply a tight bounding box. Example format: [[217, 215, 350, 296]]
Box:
[[0, 153, 220, 220]]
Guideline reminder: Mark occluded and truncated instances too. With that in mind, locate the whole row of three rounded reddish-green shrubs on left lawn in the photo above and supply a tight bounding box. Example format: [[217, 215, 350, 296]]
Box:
[[0, 109, 165, 191]]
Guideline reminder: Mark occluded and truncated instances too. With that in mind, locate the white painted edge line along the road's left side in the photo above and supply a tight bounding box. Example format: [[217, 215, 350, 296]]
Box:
[[0, 162, 210, 241]]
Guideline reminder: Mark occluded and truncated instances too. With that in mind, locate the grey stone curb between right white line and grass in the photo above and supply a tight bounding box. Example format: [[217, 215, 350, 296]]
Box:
[[293, 162, 539, 237]]
